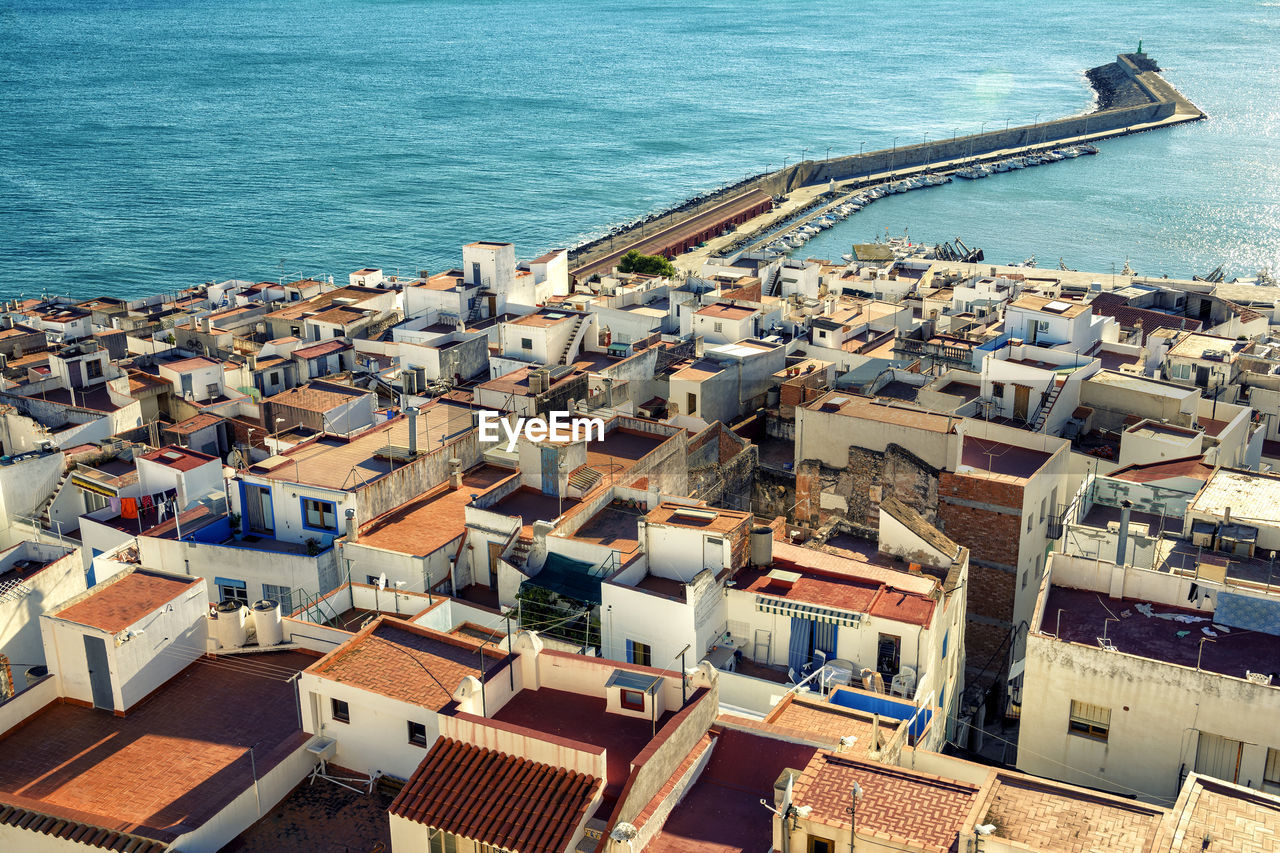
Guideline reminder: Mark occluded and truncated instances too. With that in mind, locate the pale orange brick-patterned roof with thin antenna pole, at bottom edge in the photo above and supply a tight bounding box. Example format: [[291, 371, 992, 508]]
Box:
[[794, 751, 979, 853]]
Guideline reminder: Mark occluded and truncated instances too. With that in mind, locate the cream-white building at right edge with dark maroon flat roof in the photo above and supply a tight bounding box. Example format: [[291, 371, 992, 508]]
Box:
[[1018, 555, 1280, 804]]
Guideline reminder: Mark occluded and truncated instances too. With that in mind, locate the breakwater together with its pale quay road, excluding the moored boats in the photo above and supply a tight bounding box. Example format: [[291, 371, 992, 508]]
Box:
[[570, 53, 1204, 280]]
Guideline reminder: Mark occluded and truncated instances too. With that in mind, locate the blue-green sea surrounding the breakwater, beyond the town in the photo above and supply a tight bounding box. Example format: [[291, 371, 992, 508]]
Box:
[[0, 0, 1280, 298]]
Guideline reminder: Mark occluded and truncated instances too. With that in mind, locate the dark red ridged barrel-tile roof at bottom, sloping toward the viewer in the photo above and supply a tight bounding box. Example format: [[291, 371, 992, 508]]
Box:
[[389, 738, 602, 853]]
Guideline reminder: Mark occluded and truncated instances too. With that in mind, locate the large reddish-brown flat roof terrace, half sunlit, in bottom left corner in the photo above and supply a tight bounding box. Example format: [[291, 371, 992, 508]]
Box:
[[0, 652, 315, 840]]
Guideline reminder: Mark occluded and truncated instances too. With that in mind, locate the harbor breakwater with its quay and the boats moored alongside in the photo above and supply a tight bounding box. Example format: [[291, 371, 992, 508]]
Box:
[[570, 47, 1204, 280]]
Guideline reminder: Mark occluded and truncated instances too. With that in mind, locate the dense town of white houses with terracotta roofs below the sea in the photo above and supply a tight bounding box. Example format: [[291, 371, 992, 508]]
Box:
[[0, 227, 1280, 853]]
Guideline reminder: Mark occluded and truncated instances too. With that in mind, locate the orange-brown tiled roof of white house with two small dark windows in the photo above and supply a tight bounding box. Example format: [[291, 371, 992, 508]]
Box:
[[307, 616, 506, 711]]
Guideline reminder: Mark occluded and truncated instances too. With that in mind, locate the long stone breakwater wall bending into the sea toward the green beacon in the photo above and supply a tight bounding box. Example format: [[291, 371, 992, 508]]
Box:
[[570, 54, 1204, 278]]
